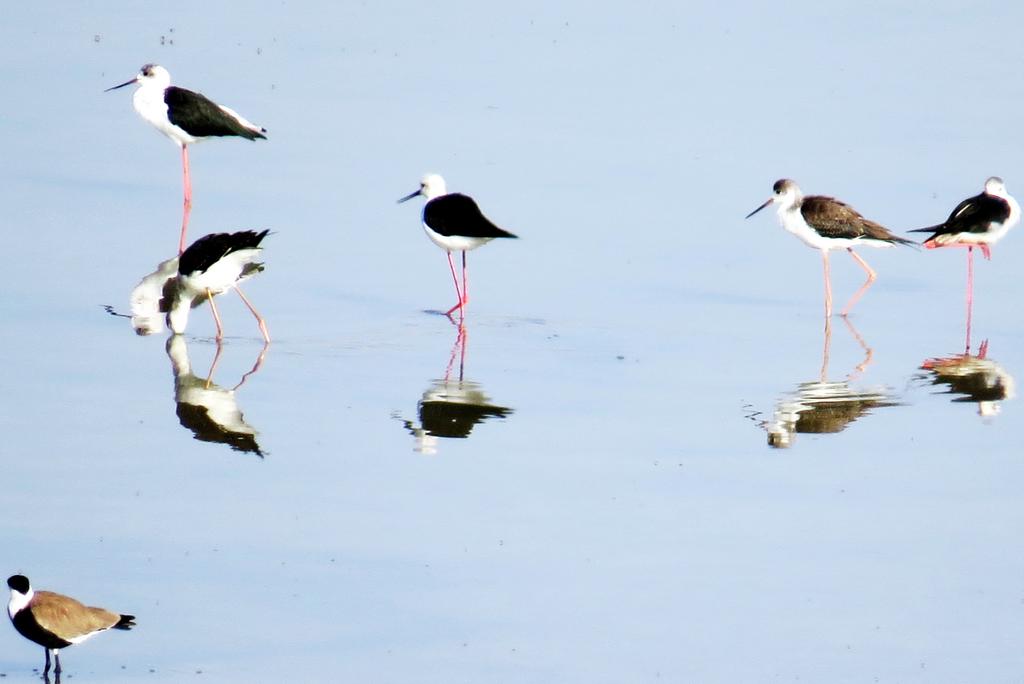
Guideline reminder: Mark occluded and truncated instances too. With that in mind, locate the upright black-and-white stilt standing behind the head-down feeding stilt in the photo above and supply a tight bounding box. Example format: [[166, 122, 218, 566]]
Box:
[[104, 65, 266, 254]]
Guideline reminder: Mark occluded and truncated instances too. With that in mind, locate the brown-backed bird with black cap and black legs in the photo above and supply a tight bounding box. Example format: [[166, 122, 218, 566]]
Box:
[[7, 574, 135, 678]]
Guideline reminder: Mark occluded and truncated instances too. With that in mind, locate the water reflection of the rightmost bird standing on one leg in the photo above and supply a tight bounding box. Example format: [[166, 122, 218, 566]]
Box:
[[918, 340, 1017, 418]]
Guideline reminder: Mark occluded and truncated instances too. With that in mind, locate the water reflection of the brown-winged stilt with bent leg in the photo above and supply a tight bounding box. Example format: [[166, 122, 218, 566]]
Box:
[[761, 316, 898, 448]]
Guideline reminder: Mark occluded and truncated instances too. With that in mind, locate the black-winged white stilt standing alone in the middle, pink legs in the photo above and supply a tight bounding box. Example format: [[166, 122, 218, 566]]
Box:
[[398, 173, 517, 317]]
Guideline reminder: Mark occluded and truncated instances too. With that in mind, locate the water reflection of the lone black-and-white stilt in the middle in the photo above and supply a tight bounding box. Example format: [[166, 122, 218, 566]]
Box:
[[396, 325, 513, 455]]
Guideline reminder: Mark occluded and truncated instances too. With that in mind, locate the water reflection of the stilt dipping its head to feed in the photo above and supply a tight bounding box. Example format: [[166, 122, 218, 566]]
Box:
[[167, 335, 269, 458]]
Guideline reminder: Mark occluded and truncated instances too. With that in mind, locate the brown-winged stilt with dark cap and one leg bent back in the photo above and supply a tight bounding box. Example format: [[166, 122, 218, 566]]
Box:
[[746, 178, 915, 317]]
